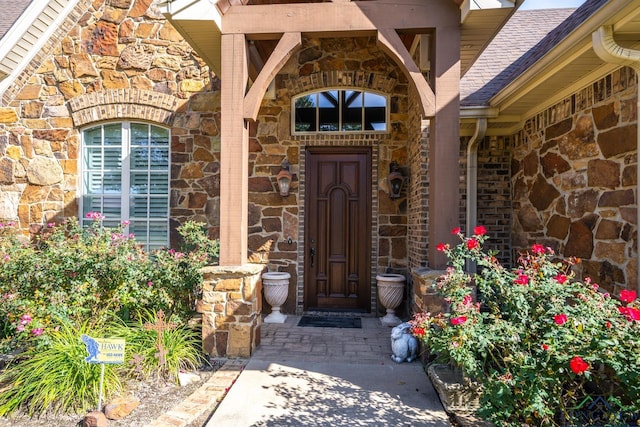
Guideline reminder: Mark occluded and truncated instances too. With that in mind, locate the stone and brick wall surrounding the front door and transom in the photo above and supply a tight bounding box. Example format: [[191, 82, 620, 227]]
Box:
[[249, 37, 408, 313]]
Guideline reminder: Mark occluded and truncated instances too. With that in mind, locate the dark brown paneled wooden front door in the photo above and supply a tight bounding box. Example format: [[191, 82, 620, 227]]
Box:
[[304, 147, 371, 312]]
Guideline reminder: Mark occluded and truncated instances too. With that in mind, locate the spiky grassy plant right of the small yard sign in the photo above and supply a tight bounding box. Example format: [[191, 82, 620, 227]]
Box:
[[110, 310, 204, 383]]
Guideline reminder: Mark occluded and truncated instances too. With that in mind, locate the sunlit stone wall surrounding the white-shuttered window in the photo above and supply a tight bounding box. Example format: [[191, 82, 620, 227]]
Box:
[[0, 0, 219, 243]]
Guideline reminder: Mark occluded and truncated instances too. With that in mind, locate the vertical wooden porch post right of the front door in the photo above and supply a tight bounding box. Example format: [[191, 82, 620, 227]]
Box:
[[429, 26, 460, 269]]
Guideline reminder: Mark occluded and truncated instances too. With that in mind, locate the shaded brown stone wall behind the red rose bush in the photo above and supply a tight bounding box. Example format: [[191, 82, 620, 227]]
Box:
[[512, 68, 638, 292]]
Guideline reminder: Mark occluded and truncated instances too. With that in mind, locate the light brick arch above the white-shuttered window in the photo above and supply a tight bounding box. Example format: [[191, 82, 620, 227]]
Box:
[[69, 89, 179, 126]]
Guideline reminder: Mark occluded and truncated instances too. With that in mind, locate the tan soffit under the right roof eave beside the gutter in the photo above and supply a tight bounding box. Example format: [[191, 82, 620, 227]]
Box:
[[482, 0, 640, 135]]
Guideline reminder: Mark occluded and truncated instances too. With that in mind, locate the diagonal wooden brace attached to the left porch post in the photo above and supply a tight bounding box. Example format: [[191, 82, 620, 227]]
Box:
[[244, 33, 302, 121]]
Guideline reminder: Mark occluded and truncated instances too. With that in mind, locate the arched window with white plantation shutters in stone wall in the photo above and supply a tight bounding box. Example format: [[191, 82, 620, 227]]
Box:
[[81, 122, 169, 250]]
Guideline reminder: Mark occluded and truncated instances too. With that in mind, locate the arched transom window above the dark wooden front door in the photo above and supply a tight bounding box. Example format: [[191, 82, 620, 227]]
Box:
[[291, 89, 389, 134]]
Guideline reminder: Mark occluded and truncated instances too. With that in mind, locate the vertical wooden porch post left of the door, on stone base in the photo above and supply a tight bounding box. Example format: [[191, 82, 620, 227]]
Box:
[[220, 34, 249, 265]]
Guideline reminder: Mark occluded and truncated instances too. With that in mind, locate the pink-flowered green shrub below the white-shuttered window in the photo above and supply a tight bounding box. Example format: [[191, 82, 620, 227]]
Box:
[[0, 213, 217, 350]]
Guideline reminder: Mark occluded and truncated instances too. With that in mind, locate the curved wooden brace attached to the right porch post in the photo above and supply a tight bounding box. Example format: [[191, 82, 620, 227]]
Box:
[[378, 28, 436, 117]]
